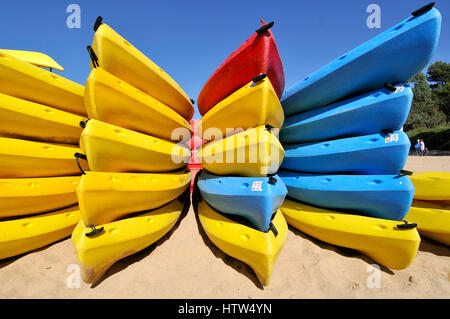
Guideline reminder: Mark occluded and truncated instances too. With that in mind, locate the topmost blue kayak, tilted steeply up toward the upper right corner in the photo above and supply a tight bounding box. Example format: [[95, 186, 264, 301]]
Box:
[[281, 5, 442, 116]]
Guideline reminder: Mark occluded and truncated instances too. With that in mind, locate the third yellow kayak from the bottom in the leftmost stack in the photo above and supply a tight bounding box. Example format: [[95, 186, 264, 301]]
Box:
[[0, 137, 89, 178]]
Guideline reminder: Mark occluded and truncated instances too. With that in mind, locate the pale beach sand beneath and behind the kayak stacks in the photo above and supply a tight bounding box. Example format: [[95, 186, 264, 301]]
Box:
[[0, 156, 450, 298]]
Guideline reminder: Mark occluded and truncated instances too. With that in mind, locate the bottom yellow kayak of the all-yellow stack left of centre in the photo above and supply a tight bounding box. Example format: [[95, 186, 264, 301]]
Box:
[[72, 199, 184, 283]]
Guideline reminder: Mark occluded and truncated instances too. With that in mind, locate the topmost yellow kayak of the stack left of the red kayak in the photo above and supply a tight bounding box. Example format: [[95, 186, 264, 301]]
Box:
[[90, 17, 194, 120]]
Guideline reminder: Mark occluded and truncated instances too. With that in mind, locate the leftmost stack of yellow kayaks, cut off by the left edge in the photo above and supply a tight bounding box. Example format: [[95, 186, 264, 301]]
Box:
[[0, 50, 89, 259]]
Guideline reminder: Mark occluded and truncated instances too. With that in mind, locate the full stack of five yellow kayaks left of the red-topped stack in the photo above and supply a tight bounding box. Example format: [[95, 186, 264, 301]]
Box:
[[72, 17, 193, 283]]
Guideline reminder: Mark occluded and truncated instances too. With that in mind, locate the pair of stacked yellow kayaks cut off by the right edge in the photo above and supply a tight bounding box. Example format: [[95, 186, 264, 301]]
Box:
[[406, 172, 450, 246]]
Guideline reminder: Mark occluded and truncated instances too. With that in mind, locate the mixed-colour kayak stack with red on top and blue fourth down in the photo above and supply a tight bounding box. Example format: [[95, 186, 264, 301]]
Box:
[[195, 23, 287, 286]]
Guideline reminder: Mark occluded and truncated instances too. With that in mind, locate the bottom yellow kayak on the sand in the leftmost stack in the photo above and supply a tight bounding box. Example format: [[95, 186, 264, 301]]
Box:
[[0, 206, 80, 259]]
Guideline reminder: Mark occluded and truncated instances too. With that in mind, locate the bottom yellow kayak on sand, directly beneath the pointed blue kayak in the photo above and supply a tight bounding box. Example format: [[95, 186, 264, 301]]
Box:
[[198, 201, 288, 286]]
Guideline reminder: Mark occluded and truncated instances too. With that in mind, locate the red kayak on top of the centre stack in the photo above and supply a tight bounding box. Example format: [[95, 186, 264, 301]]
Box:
[[197, 20, 284, 115]]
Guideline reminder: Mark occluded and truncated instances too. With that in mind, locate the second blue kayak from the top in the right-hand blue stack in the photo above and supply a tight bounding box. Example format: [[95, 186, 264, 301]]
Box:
[[280, 84, 413, 144]]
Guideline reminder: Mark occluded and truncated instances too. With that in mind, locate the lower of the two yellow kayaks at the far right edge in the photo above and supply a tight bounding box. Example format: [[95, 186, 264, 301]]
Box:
[[406, 200, 450, 246]]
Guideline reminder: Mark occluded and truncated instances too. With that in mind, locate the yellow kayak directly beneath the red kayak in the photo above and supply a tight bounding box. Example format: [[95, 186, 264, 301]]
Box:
[[197, 77, 284, 140]]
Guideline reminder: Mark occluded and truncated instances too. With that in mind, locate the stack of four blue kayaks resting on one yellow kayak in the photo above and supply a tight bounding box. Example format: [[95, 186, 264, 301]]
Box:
[[278, 3, 441, 268]]
